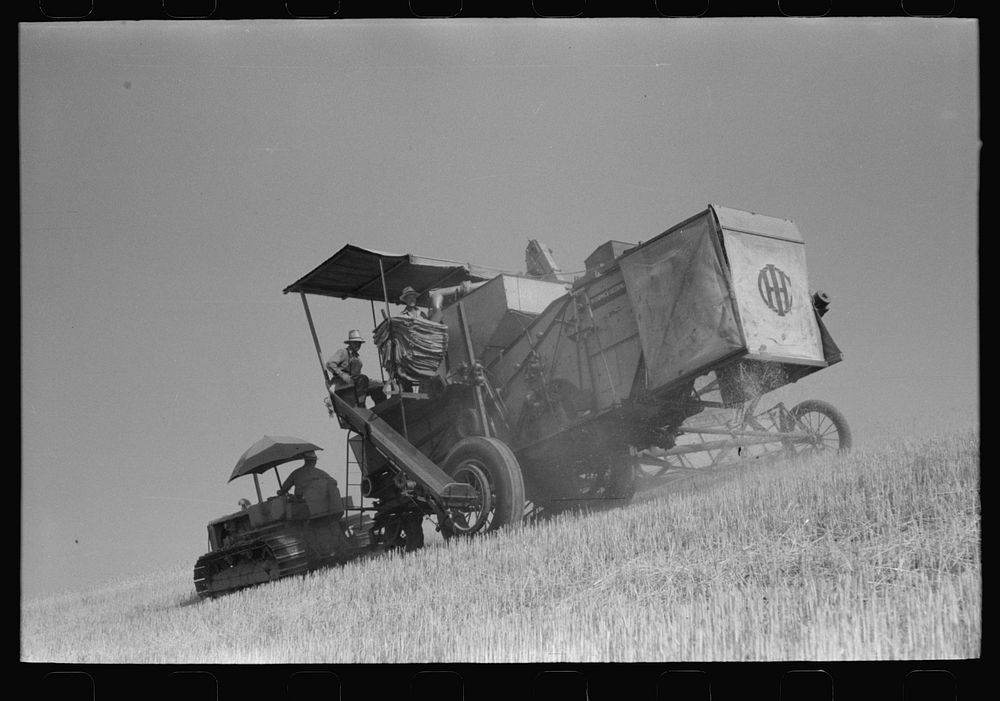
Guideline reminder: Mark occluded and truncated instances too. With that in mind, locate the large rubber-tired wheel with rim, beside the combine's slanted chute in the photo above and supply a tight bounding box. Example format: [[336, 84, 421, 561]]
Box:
[[443, 436, 524, 537]]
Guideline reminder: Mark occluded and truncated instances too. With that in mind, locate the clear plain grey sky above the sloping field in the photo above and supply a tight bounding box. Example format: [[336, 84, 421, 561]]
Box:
[[18, 18, 981, 597]]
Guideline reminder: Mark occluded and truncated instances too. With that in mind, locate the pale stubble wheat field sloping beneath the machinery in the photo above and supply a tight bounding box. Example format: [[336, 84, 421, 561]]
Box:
[[20, 425, 982, 664]]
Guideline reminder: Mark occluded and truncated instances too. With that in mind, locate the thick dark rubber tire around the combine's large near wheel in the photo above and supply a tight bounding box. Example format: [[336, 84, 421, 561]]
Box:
[[442, 436, 524, 533]]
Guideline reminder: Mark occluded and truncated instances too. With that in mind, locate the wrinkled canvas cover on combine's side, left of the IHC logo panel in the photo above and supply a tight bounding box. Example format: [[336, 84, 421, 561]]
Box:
[[619, 210, 745, 391]]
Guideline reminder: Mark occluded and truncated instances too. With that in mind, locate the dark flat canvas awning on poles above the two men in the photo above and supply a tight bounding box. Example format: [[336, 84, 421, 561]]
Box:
[[284, 244, 503, 304]]
